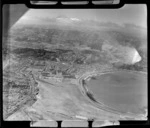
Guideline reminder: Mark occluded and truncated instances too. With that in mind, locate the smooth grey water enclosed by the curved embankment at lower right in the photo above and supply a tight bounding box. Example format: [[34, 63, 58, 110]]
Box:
[[86, 71, 147, 114]]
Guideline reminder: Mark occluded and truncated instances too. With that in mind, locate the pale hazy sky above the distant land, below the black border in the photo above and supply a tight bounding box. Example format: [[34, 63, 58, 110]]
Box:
[[18, 4, 147, 28]]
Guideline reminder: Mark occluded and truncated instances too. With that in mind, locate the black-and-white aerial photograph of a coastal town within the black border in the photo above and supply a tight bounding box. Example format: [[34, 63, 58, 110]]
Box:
[[2, 4, 148, 127]]
